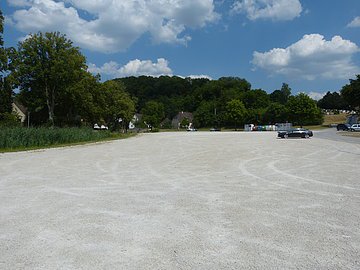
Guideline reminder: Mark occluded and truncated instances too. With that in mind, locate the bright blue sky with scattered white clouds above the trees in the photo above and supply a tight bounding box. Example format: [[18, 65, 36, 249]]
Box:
[[1, 0, 360, 98]]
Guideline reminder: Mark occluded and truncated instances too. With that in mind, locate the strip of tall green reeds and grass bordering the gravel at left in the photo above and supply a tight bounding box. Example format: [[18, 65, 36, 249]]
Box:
[[0, 128, 133, 152]]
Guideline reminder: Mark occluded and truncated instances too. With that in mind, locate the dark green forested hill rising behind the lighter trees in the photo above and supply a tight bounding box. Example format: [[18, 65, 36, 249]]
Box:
[[114, 76, 252, 119]]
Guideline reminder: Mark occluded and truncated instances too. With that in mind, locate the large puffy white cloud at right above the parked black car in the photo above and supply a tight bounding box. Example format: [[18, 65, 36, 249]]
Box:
[[252, 34, 360, 80]]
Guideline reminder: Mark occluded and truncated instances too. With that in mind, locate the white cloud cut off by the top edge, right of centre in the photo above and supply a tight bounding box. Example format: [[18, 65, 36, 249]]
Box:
[[231, 0, 302, 21]]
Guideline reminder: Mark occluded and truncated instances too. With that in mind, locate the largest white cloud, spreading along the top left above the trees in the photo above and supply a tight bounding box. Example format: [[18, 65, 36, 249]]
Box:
[[8, 0, 220, 52]]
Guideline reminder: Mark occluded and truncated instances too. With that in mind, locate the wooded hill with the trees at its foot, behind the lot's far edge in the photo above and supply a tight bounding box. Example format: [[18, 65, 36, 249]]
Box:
[[113, 76, 323, 129]]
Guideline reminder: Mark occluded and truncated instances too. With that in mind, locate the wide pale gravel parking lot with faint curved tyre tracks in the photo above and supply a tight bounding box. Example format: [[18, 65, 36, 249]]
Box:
[[0, 132, 360, 269]]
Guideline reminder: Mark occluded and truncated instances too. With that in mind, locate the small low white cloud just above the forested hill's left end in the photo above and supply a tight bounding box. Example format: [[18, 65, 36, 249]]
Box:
[[88, 58, 172, 78]]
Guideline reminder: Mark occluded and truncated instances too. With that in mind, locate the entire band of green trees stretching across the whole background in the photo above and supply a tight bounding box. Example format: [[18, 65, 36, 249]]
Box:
[[0, 11, 360, 129]]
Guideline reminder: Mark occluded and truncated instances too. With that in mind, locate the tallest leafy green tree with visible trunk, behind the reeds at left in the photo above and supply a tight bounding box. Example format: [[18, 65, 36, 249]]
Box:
[[17, 32, 86, 125]]
